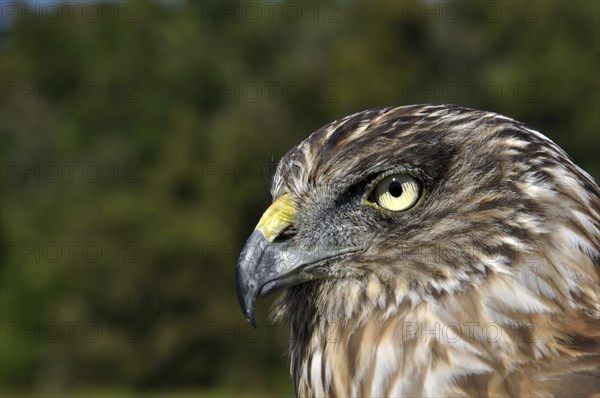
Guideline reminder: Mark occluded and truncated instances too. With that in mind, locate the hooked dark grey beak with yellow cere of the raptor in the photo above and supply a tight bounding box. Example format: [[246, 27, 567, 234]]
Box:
[[236, 194, 356, 327]]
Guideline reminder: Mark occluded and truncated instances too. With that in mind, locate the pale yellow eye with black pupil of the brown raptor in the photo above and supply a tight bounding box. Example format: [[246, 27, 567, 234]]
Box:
[[369, 174, 422, 211]]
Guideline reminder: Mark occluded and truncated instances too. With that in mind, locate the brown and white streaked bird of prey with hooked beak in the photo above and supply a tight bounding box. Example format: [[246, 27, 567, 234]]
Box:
[[237, 105, 600, 397]]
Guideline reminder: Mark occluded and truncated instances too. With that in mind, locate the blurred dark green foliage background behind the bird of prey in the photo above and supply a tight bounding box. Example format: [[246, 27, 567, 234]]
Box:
[[0, 1, 600, 396]]
